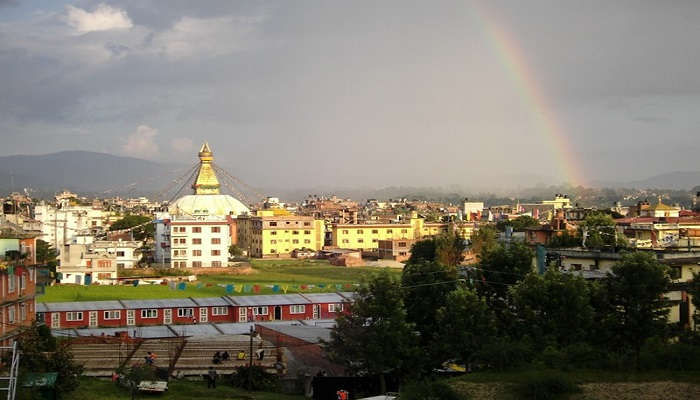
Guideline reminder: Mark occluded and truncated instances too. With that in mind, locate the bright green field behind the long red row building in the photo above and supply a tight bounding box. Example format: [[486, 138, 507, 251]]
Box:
[[37, 260, 401, 302]]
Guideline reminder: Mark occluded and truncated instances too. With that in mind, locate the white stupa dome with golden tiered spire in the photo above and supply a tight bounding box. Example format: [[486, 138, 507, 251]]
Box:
[[168, 143, 250, 217]]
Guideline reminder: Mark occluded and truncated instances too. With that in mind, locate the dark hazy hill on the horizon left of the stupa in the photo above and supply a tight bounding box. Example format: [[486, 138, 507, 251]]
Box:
[[0, 151, 183, 195]]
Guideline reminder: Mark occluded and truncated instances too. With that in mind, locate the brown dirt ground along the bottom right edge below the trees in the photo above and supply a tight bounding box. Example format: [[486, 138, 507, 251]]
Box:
[[454, 381, 700, 400]]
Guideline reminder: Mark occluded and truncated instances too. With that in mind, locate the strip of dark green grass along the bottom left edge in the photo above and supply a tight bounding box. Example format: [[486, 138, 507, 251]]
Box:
[[17, 378, 304, 400]]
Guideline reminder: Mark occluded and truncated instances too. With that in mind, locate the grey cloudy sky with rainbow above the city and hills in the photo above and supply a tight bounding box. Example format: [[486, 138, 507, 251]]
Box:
[[0, 0, 700, 187]]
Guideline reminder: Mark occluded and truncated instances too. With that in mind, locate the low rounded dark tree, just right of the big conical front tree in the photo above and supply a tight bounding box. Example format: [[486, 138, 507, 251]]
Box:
[[437, 288, 497, 362]]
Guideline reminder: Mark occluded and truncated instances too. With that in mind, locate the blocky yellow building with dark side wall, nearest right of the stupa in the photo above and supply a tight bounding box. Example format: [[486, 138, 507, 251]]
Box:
[[236, 210, 325, 258]]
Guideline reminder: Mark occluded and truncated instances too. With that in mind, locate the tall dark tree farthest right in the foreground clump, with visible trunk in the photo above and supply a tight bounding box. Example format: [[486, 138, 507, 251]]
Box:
[[605, 252, 671, 367]]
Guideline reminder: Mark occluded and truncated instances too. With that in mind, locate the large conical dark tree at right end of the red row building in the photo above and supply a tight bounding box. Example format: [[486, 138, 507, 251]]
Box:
[[324, 271, 419, 392]]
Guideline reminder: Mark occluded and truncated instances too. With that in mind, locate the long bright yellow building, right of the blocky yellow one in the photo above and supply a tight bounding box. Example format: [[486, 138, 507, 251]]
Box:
[[331, 212, 475, 250]]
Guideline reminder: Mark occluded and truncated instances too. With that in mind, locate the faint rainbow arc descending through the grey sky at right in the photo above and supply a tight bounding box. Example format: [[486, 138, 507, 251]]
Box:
[[474, 6, 586, 186]]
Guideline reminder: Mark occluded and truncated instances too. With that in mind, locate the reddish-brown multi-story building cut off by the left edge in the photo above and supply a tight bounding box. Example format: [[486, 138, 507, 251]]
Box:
[[0, 217, 37, 346]]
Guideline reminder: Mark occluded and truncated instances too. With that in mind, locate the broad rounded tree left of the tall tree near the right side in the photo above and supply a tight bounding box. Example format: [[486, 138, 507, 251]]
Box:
[[510, 269, 593, 350]]
